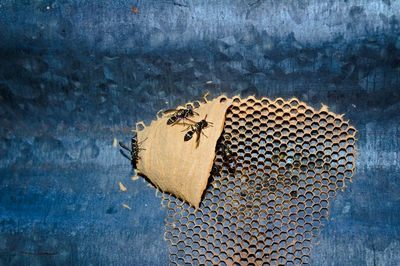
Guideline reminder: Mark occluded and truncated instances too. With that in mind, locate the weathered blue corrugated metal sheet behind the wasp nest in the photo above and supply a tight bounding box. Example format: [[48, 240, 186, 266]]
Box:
[[0, 0, 400, 265]]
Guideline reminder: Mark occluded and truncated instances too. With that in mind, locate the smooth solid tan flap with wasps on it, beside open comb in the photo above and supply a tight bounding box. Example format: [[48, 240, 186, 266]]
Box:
[[137, 96, 232, 207]]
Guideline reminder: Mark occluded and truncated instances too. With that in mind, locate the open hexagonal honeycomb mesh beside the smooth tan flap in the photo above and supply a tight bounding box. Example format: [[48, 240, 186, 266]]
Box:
[[162, 96, 356, 265]]
